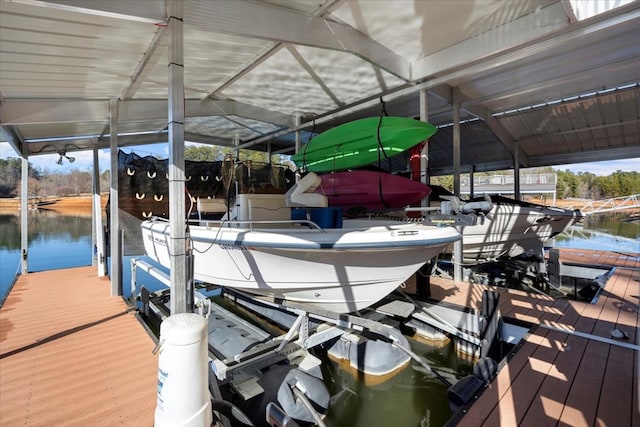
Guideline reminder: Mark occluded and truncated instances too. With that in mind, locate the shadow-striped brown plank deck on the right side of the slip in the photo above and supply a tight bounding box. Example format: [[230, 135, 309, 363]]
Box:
[[418, 249, 640, 427]]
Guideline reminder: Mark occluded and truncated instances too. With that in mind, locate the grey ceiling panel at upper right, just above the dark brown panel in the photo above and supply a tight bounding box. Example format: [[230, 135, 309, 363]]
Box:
[[452, 9, 640, 112]]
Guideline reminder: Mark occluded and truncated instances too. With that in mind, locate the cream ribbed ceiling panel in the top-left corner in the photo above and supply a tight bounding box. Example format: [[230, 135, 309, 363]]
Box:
[[0, 1, 155, 98]]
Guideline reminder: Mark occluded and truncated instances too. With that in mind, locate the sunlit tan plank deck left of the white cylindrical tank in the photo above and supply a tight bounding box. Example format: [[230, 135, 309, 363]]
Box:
[[0, 267, 158, 427]]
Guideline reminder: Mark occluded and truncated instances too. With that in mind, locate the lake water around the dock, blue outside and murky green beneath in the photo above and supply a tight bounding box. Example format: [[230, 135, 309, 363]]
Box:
[[0, 210, 640, 427]]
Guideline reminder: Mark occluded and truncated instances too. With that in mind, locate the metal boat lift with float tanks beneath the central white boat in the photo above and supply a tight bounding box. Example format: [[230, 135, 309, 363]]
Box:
[[131, 259, 468, 425]]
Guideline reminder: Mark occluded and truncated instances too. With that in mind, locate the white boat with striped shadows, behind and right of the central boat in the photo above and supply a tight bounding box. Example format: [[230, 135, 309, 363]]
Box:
[[432, 195, 582, 262]]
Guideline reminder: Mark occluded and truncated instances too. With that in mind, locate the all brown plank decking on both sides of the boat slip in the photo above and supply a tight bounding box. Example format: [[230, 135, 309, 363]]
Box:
[[0, 249, 640, 427]]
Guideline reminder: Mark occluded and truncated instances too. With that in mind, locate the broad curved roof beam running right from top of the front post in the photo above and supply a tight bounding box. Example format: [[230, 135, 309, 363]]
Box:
[[184, 0, 411, 81]]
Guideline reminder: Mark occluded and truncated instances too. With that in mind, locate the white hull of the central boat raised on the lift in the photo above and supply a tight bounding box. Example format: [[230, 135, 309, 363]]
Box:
[[142, 221, 460, 313]]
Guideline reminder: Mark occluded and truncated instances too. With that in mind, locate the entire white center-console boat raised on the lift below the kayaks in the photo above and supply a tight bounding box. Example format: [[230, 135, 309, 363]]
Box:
[[141, 173, 460, 313]]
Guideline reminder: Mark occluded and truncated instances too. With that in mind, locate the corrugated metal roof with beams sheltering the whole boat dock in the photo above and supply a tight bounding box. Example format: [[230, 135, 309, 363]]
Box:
[[0, 0, 640, 175]]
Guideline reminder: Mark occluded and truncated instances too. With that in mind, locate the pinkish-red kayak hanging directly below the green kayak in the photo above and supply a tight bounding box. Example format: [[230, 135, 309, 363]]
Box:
[[316, 170, 431, 212]]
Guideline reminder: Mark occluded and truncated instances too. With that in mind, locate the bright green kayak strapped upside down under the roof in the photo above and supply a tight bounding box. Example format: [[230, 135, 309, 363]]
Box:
[[291, 116, 437, 172]]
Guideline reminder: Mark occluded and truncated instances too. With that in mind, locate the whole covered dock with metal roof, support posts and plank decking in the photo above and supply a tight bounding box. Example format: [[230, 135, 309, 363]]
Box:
[[0, 0, 640, 426]]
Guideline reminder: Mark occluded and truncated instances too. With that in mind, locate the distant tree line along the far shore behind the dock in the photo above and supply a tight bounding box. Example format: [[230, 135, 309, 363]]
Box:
[[0, 154, 640, 200]]
